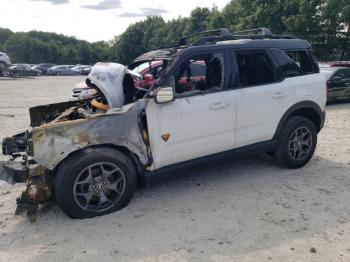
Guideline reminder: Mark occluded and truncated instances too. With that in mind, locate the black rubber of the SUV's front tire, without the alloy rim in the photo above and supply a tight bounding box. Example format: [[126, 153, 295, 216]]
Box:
[[54, 148, 137, 218]]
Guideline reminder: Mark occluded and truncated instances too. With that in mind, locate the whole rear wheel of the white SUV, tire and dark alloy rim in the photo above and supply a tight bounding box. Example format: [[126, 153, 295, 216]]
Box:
[[274, 116, 317, 168]]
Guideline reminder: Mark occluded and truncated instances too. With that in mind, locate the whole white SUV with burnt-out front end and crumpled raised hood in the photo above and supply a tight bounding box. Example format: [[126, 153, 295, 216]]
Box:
[[0, 28, 326, 219]]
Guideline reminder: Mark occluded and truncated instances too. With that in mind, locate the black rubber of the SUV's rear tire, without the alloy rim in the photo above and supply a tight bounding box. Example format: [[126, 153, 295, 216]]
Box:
[[274, 117, 317, 168]]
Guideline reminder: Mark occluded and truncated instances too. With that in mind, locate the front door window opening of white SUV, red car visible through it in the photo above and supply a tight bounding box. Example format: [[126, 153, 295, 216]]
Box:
[[171, 53, 224, 96]]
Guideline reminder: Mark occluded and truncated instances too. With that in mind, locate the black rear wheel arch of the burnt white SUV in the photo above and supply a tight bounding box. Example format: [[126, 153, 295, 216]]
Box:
[[273, 101, 324, 139]]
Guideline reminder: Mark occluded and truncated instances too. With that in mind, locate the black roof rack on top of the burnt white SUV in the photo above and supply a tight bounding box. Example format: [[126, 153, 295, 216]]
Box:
[[171, 27, 295, 47]]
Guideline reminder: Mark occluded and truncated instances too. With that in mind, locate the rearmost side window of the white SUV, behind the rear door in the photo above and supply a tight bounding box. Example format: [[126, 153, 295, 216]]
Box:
[[271, 48, 317, 77]]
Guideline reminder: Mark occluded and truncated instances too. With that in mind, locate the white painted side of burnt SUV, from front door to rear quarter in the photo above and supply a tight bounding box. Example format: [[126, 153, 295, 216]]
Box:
[[146, 74, 326, 169]]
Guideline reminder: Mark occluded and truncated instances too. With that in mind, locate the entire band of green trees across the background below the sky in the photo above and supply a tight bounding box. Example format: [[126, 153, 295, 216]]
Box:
[[0, 0, 350, 64]]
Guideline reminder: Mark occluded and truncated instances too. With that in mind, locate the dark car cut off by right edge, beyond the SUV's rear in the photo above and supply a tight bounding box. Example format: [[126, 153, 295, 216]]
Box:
[[320, 67, 350, 102]]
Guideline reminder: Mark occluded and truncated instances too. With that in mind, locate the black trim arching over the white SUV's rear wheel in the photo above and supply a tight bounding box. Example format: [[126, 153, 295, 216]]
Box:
[[273, 101, 325, 139]]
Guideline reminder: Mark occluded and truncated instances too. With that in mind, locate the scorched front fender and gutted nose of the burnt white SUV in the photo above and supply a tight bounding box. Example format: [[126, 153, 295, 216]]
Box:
[[0, 99, 151, 220]]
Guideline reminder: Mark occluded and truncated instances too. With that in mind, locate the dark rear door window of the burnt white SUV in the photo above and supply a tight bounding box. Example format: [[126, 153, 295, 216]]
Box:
[[236, 51, 274, 86]]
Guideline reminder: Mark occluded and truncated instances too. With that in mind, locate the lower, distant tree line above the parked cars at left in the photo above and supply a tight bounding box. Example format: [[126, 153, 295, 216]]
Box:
[[0, 28, 110, 64]]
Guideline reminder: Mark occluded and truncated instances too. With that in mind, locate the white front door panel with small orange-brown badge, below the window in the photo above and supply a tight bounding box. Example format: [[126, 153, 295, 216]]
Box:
[[146, 90, 237, 169]]
